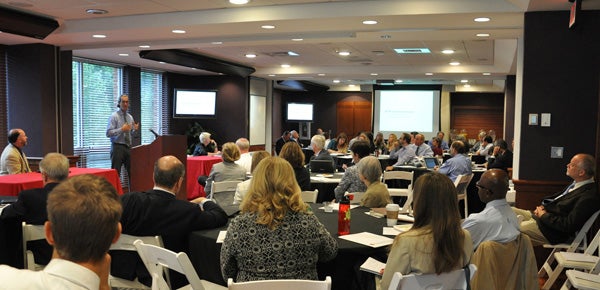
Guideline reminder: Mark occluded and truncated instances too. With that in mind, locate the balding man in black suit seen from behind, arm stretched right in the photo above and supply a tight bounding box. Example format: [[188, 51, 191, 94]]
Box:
[[111, 156, 227, 288]]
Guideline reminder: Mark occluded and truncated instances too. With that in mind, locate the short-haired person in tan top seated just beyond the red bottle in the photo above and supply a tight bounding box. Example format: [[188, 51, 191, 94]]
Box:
[[355, 156, 392, 208]]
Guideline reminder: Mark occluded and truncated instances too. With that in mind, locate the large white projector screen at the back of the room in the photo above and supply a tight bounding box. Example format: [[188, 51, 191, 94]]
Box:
[[373, 90, 440, 140]]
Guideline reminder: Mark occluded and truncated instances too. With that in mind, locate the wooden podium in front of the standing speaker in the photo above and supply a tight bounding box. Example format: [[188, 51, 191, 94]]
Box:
[[129, 135, 187, 200]]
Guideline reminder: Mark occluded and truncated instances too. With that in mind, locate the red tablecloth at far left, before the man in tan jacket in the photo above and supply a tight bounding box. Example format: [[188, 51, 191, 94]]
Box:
[[0, 167, 123, 195]]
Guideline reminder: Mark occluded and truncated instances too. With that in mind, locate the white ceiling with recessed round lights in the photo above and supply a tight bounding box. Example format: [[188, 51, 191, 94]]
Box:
[[0, 0, 600, 89]]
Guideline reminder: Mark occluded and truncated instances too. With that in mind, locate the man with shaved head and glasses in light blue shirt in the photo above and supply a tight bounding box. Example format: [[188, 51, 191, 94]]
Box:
[[462, 169, 520, 249]]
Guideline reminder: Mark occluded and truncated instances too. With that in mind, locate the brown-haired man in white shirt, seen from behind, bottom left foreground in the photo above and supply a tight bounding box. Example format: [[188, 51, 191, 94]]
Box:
[[0, 175, 121, 290]]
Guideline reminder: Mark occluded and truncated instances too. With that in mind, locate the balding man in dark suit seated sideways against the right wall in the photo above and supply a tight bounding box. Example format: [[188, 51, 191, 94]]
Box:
[[513, 154, 600, 246]]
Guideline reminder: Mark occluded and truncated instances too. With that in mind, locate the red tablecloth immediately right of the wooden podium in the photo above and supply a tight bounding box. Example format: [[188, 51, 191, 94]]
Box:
[[185, 156, 223, 200]]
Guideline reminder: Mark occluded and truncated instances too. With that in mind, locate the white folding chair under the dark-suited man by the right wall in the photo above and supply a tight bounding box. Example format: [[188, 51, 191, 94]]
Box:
[[538, 211, 600, 289]]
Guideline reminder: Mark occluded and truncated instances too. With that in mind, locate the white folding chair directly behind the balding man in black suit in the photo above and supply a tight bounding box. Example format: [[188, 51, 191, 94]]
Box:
[[108, 234, 165, 289]]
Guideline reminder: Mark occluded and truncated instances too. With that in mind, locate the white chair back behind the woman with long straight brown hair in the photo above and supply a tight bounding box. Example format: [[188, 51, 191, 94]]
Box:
[[388, 264, 477, 290]]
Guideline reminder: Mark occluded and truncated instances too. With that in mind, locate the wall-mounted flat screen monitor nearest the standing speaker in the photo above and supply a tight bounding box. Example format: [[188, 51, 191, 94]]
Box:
[[173, 89, 217, 118]]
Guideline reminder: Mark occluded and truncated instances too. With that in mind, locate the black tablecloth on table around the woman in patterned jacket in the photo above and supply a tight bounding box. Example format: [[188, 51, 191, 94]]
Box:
[[190, 204, 387, 289]]
